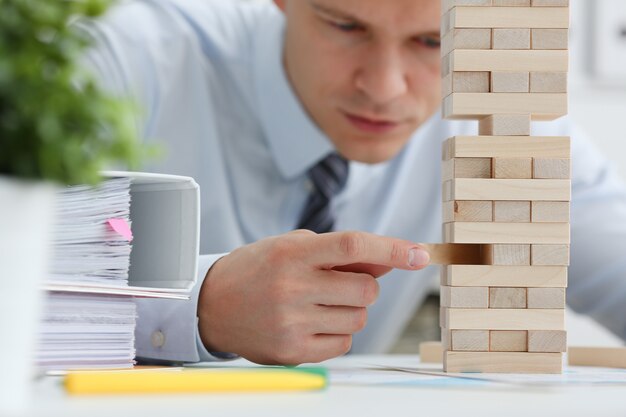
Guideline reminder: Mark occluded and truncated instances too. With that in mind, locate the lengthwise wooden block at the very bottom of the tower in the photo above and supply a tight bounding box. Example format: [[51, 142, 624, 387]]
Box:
[[443, 352, 563, 374]]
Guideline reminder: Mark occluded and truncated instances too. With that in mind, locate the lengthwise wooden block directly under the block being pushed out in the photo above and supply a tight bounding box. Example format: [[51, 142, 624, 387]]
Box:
[[441, 265, 567, 288]]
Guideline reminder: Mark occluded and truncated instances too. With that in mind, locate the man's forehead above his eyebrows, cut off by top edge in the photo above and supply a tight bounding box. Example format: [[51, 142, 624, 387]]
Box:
[[304, 0, 440, 32]]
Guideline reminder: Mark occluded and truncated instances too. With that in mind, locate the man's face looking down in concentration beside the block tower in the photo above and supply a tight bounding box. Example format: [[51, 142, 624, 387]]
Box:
[[275, 0, 441, 163]]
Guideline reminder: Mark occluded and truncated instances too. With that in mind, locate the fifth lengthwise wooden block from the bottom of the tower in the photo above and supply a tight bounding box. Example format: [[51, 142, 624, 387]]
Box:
[[444, 178, 571, 200]]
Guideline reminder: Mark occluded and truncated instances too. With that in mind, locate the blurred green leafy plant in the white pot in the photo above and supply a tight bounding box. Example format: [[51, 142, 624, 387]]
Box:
[[0, 0, 143, 184]]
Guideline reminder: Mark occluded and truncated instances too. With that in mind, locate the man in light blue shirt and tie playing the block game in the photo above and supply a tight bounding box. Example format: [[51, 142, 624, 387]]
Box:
[[83, 0, 626, 364]]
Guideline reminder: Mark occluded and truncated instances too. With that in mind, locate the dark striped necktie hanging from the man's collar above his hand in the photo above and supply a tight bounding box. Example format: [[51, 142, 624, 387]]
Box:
[[298, 153, 348, 233]]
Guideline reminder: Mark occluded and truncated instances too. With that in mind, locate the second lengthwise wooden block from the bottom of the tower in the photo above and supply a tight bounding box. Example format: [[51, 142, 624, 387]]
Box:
[[441, 307, 565, 330]]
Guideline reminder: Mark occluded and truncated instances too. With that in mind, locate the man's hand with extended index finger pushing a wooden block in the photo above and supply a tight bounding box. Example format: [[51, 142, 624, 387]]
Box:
[[198, 230, 429, 365]]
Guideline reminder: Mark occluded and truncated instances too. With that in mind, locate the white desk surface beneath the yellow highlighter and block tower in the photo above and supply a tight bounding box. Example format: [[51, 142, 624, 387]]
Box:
[[27, 355, 626, 417]]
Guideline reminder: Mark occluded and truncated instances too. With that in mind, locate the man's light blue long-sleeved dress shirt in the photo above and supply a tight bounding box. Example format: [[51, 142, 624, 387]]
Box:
[[83, 0, 626, 361]]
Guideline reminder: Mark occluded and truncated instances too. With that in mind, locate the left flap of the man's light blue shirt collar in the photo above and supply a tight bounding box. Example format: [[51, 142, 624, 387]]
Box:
[[254, 6, 334, 179]]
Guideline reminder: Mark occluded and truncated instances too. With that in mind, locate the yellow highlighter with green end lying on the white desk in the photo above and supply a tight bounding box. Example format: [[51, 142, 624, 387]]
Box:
[[65, 367, 328, 395]]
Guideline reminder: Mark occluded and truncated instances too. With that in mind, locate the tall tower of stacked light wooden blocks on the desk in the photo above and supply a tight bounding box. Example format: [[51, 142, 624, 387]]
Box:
[[441, 0, 570, 373]]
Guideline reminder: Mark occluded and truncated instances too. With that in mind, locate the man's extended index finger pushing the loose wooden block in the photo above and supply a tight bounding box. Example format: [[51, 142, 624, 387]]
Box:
[[308, 232, 430, 270]]
